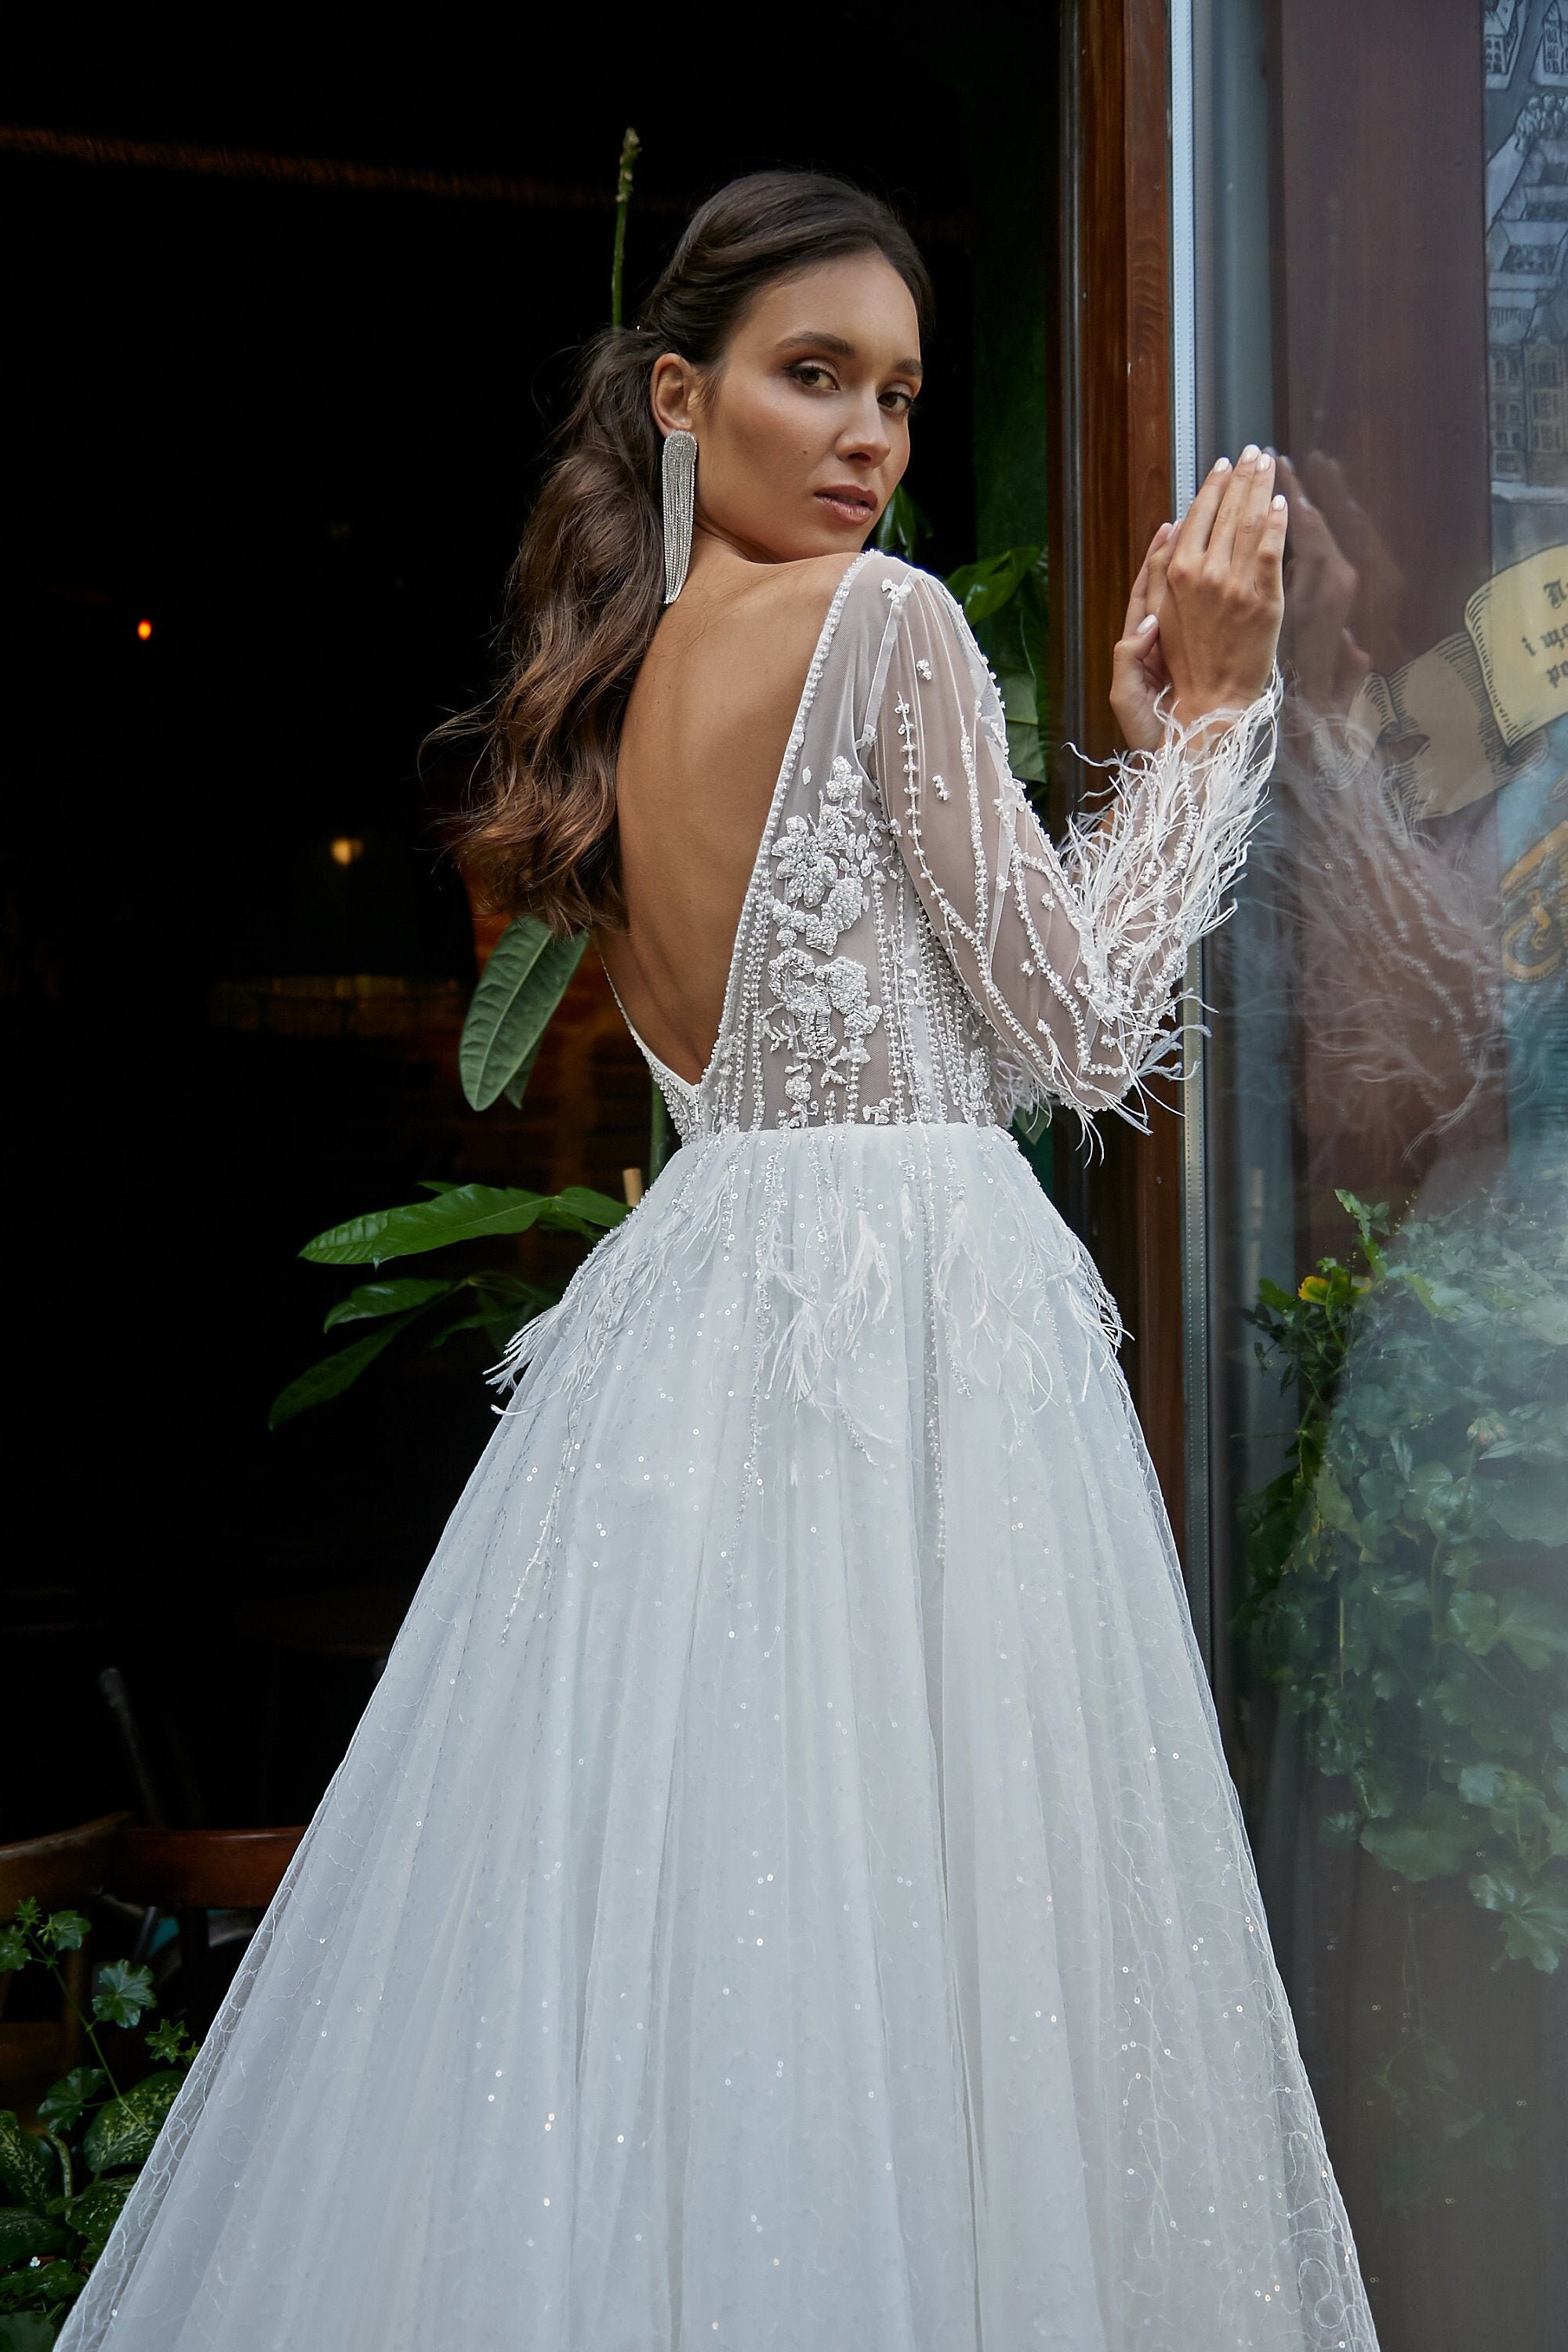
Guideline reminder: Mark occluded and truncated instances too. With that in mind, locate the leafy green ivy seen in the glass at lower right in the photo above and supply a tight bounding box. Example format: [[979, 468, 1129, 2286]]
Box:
[[1236, 1169, 1568, 1973]]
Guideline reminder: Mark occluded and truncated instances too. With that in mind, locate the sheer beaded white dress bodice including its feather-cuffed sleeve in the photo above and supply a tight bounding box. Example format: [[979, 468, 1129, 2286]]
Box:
[[606, 550, 1279, 1143]]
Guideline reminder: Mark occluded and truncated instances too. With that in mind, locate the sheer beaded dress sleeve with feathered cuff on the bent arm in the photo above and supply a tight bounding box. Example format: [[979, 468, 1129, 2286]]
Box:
[[865, 564, 1281, 1127]]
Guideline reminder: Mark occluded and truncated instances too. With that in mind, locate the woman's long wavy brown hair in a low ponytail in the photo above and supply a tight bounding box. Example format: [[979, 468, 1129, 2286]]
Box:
[[435, 172, 931, 934]]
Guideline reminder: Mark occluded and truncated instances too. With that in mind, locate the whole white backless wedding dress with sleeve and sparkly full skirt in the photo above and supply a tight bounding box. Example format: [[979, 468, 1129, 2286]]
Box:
[[59, 553, 1375, 2352]]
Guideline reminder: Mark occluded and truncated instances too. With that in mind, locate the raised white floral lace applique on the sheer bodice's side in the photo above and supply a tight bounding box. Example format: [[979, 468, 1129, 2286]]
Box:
[[762, 753, 891, 1127]]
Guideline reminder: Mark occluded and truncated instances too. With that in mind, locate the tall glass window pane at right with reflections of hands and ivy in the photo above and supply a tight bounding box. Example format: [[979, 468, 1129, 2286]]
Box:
[[1199, 0, 1568, 2352]]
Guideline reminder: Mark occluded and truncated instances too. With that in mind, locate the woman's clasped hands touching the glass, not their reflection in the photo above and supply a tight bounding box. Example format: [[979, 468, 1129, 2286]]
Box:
[[1112, 445, 1288, 750]]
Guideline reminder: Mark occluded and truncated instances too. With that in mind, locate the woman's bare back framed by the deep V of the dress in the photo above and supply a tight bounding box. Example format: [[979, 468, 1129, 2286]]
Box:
[[595, 548, 846, 1082]]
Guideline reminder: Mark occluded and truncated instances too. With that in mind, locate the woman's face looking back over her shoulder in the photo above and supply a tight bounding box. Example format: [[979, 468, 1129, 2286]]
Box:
[[654, 252, 919, 562]]
